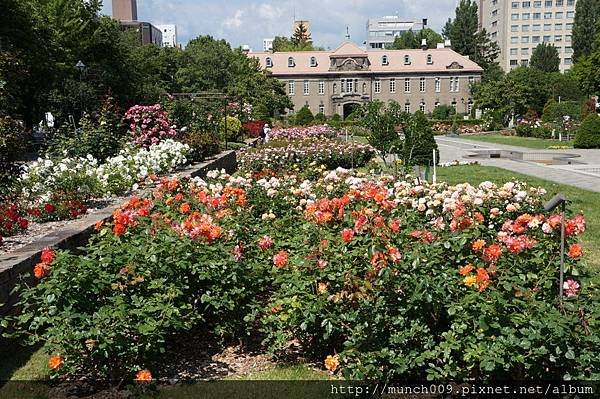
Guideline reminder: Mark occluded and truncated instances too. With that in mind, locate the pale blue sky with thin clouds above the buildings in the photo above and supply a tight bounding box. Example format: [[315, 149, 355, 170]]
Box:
[[103, 0, 458, 51]]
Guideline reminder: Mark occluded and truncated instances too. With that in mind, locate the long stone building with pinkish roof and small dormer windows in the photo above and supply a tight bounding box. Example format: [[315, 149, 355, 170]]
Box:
[[249, 41, 483, 118]]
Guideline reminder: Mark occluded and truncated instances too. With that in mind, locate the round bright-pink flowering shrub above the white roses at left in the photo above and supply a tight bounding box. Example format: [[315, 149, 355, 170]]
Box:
[[123, 104, 177, 147]]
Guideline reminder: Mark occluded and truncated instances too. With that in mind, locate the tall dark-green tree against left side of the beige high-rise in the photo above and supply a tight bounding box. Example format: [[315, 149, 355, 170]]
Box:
[[442, 0, 500, 69]]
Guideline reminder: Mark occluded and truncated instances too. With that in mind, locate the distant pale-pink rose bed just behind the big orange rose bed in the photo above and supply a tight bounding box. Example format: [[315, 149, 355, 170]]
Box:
[[238, 138, 375, 171]]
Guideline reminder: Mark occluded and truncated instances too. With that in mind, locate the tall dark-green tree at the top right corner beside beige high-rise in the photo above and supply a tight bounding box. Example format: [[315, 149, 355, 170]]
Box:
[[573, 0, 600, 60]]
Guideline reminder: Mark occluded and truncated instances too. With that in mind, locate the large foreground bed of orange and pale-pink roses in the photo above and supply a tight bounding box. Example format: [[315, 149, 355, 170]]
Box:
[[7, 170, 600, 380]]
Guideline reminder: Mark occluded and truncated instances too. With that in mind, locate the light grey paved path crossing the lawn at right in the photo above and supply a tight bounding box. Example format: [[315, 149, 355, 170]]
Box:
[[436, 136, 600, 192]]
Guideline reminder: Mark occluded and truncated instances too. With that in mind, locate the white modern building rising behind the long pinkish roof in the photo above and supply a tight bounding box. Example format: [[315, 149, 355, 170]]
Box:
[[366, 16, 427, 49]]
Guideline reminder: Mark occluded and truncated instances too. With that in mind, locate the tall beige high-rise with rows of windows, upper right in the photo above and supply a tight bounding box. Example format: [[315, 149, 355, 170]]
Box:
[[479, 0, 576, 71]]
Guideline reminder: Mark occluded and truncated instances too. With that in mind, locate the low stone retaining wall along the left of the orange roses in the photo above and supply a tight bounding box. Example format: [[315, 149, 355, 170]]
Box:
[[0, 147, 239, 316]]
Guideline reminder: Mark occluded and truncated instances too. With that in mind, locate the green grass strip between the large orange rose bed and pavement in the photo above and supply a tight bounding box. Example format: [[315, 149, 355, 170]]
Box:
[[438, 165, 600, 270]]
